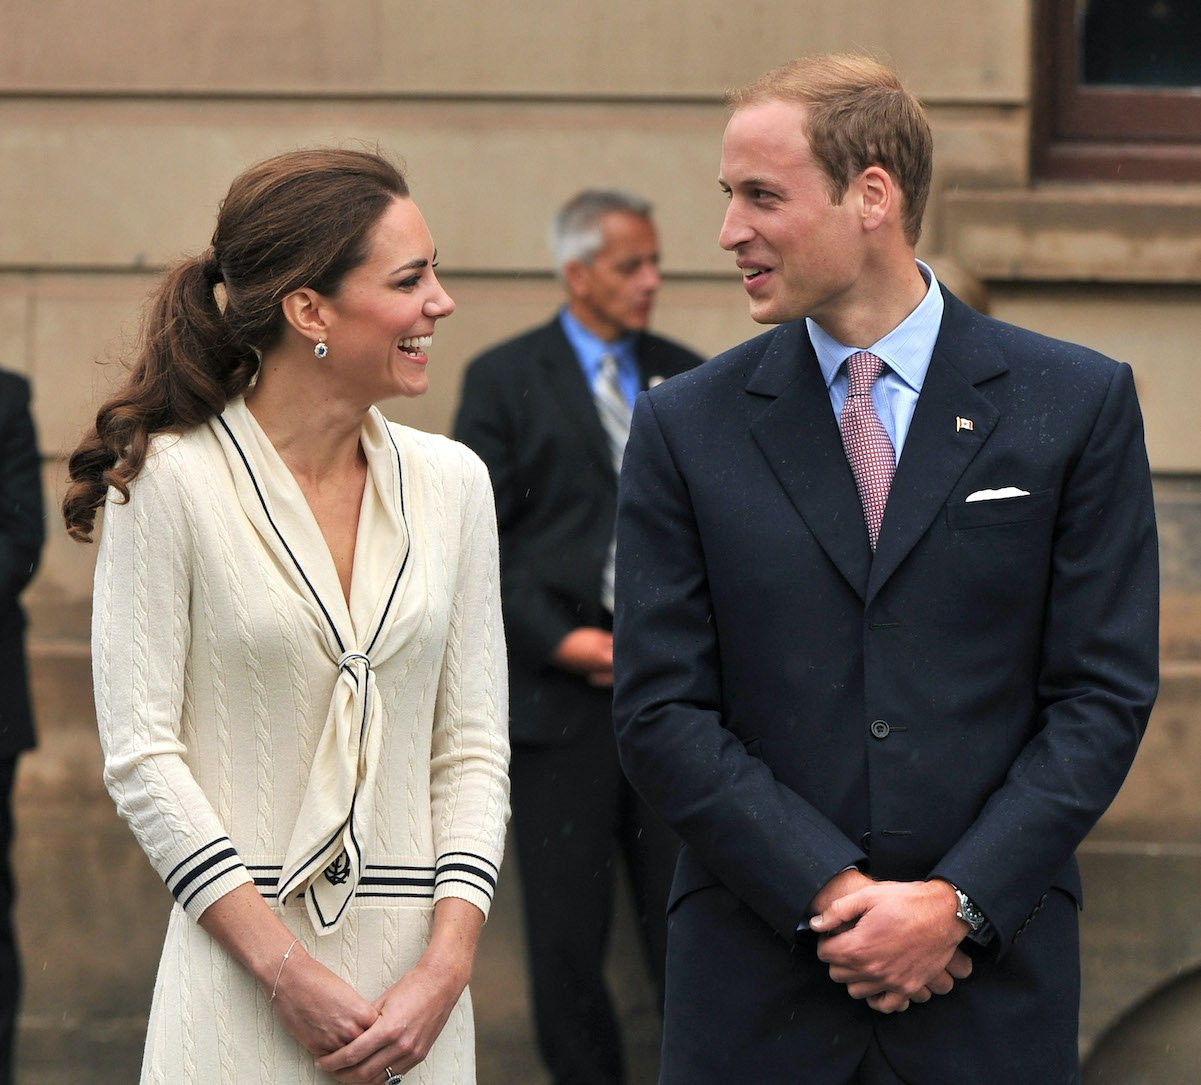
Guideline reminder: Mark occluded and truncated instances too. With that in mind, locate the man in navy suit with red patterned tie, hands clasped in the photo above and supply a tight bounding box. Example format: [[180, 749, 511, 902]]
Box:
[[615, 56, 1158, 1085]]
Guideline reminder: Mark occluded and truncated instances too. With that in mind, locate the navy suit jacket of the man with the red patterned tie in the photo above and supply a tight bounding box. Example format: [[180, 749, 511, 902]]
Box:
[[615, 292, 1158, 1083]]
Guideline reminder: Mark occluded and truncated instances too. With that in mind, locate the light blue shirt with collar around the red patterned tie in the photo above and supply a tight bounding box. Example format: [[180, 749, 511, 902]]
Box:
[[805, 260, 943, 460]]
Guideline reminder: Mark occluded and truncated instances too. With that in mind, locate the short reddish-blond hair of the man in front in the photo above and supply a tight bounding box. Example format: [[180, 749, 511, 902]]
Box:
[[727, 54, 934, 245]]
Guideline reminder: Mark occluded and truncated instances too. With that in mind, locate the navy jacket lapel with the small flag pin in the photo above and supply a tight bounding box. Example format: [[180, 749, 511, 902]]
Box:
[[867, 292, 1008, 602]]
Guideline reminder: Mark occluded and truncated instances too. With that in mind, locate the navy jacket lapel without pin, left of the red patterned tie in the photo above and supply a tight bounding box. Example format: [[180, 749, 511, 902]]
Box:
[[746, 322, 872, 598]]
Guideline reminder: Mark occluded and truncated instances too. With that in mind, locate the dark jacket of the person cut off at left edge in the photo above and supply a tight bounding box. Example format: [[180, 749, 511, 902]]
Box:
[[0, 370, 46, 757]]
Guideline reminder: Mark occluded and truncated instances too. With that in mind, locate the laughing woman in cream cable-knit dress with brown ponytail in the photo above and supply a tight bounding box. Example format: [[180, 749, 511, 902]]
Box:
[[64, 150, 508, 1085]]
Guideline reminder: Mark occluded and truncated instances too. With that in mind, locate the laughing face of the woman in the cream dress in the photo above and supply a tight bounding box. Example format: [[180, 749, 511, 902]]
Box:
[[324, 198, 454, 403]]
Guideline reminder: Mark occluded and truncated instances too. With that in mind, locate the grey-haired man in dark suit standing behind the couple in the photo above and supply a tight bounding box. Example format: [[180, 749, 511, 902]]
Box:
[[455, 191, 700, 1085]]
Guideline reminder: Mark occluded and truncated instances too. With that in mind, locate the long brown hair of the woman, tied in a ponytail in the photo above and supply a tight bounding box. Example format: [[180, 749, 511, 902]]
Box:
[[62, 149, 408, 542]]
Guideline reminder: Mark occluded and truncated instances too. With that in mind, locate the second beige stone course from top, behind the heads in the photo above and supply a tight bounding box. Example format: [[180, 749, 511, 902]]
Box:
[[0, 100, 1026, 275]]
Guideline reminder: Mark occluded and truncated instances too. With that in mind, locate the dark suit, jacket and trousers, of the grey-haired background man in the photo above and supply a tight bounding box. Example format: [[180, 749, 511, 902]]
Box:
[[455, 317, 701, 1081]]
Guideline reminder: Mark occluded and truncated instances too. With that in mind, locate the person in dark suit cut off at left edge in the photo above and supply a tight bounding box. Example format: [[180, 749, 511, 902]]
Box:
[[0, 370, 46, 1085]]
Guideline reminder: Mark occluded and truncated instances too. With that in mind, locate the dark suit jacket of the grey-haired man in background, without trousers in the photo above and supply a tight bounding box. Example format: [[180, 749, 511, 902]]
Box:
[[454, 317, 701, 744]]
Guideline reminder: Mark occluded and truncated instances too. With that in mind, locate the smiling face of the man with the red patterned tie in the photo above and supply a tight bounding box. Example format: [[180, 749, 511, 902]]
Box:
[[718, 101, 865, 334]]
